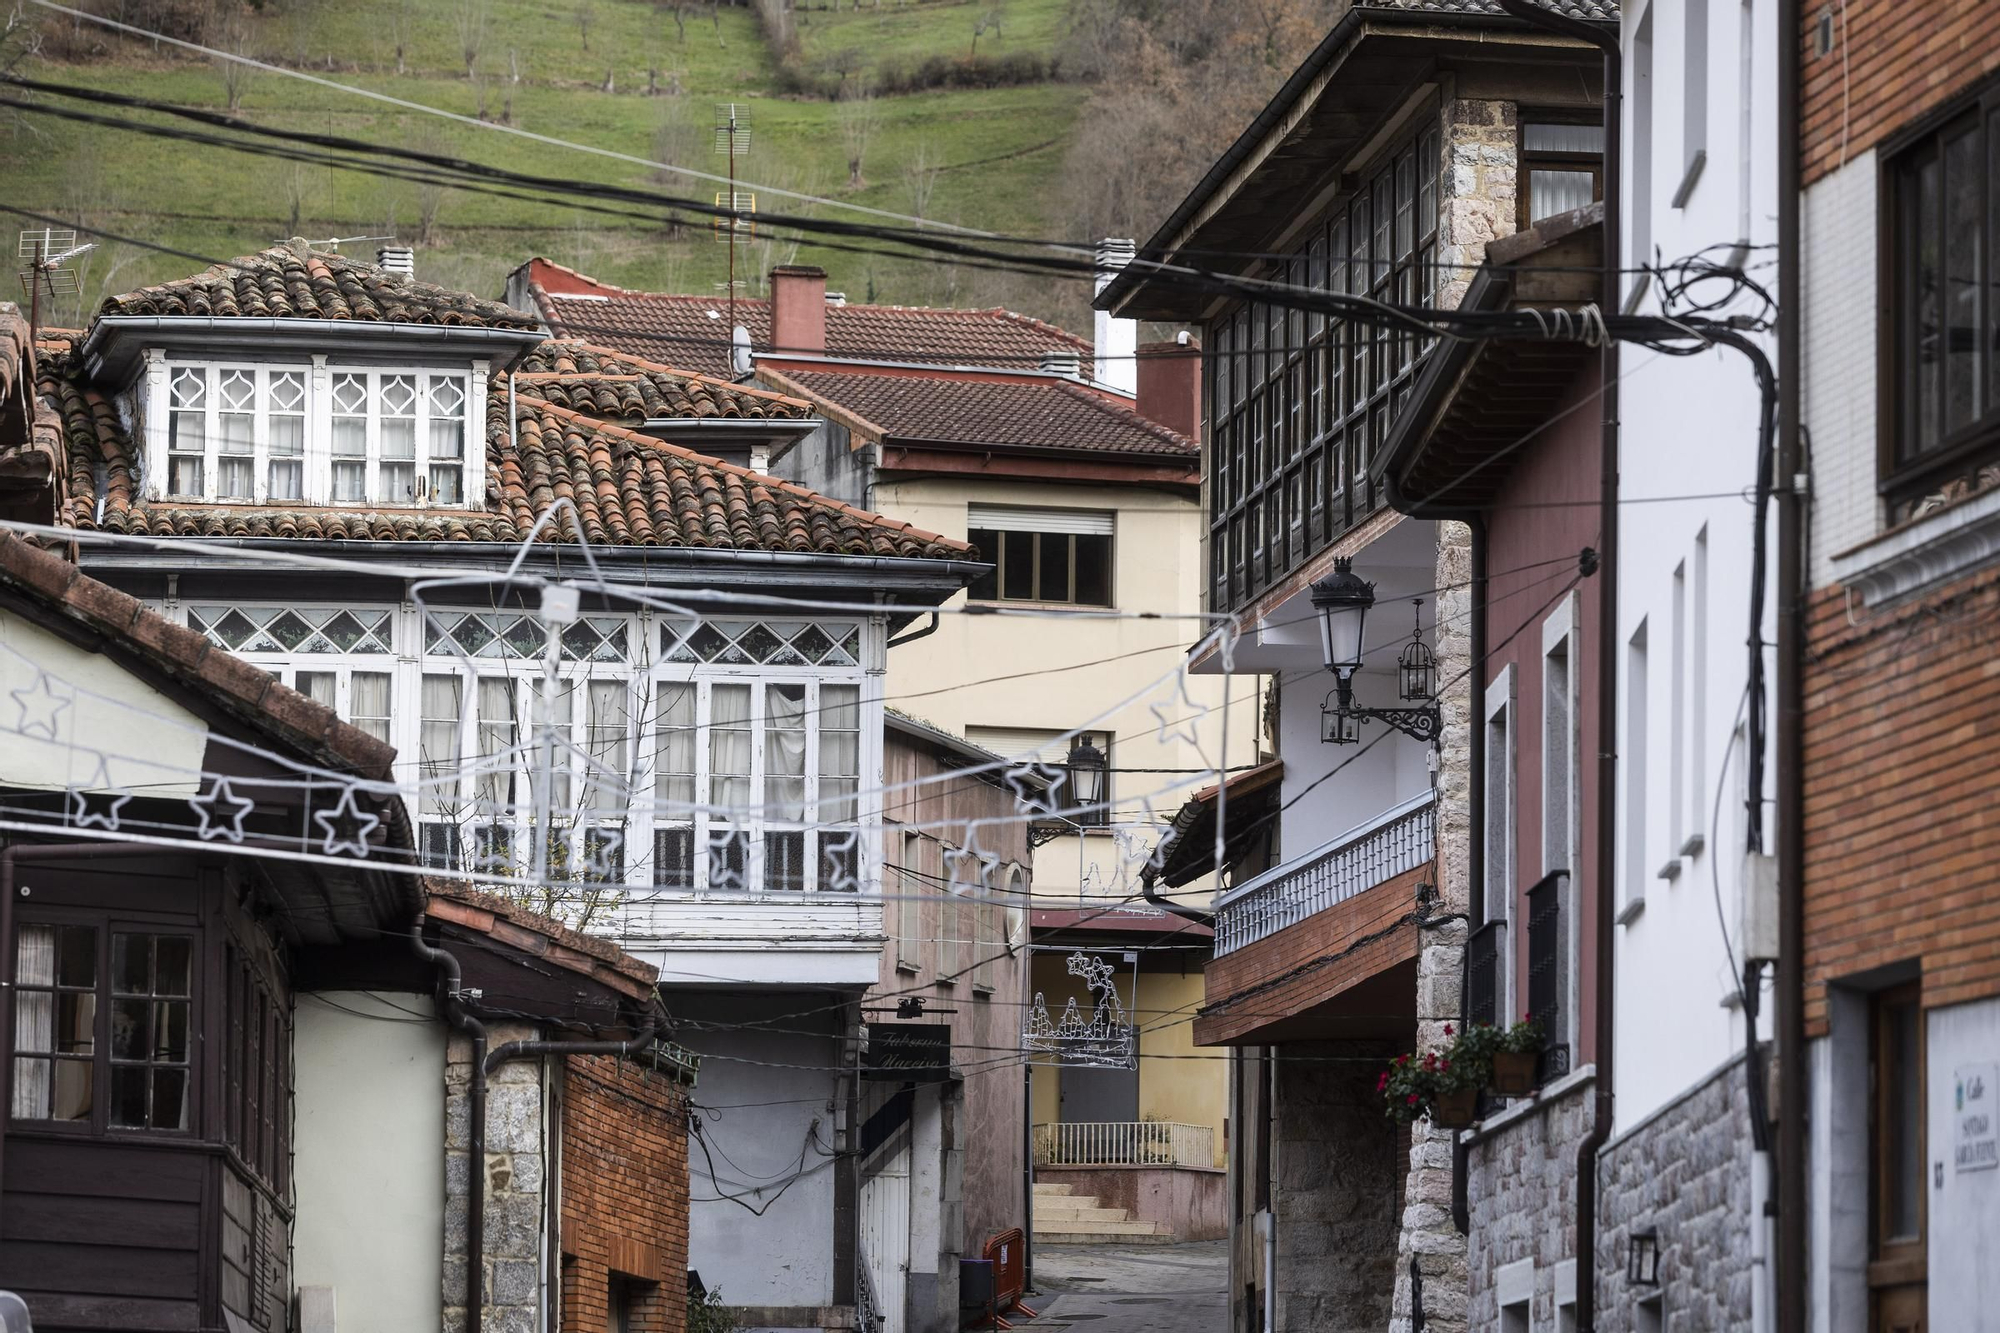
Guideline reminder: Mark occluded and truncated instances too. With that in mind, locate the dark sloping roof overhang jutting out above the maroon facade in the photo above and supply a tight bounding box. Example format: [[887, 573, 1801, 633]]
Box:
[[1376, 204, 1604, 518]]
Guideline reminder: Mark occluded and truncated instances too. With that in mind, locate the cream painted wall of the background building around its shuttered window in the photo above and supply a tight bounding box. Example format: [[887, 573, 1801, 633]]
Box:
[[874, 478, 1260, 901]]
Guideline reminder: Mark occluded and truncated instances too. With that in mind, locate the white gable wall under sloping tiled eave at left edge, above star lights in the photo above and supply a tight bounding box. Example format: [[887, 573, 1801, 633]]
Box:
[[0, 614, 208, 797]]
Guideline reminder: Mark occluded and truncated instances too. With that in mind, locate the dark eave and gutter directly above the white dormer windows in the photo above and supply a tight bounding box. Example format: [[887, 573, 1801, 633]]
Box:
[[78, 314, 548, 382]]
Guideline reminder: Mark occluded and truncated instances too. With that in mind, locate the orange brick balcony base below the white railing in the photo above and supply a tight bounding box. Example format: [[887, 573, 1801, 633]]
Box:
[[1194, 865, 1438, 1047]]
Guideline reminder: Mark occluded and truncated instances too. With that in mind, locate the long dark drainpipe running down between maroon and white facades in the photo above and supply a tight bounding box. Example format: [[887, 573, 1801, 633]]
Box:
[[1498, 0, 1616, 1333]]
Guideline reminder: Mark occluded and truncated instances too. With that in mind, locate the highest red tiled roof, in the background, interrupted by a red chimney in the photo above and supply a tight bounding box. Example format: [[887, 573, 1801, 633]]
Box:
[[528, 258, 1090, 376]]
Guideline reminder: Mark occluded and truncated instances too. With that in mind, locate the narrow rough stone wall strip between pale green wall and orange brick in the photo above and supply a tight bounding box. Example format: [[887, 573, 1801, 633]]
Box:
[[444, 1023, 546, 1333]]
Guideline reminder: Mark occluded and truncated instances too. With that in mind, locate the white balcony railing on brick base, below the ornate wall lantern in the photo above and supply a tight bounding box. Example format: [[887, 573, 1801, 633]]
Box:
[[1216, 791, 1438, 959]]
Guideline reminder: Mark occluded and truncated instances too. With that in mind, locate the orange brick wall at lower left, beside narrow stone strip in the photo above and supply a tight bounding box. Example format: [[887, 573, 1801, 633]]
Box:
[[562, 1055, 688, 1333]]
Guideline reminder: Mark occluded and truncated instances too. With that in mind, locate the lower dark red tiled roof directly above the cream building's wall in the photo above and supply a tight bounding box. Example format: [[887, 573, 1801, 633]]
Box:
[[764, 366, 1200, 456]]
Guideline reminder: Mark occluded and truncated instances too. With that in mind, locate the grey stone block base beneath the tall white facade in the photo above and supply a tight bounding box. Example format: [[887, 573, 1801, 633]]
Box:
[[1598, 1057, 1750, 1329]]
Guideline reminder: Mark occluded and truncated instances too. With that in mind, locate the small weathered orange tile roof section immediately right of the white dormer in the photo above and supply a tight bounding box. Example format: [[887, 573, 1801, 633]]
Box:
[[514, 338, 814, 422]]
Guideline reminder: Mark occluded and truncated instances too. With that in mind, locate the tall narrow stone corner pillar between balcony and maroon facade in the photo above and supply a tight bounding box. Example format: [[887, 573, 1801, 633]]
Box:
[[1388, 520, 1488, 1333]]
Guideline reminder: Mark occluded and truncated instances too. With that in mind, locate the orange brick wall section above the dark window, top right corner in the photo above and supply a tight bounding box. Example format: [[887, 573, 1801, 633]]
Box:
[[1800, 0, 2000, 186]]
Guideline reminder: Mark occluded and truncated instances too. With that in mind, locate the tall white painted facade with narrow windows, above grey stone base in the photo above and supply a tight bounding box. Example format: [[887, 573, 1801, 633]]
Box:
[[1610, 0, 1778, 1127]]
